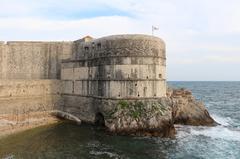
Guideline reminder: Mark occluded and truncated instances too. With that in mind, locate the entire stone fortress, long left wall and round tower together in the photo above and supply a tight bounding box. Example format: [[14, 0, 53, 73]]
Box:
[[0, 34, 214, 137]]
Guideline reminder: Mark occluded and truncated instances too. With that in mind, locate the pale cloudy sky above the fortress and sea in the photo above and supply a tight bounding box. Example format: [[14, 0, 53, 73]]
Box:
[[0, 0, 240, 81]]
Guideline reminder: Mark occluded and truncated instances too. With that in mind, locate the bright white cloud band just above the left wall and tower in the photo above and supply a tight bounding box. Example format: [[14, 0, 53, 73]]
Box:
[[0, 16, 140, 41]]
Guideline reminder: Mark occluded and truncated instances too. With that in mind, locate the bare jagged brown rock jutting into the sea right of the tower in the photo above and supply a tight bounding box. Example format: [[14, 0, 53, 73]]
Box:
[[167, 88, 217, 126]]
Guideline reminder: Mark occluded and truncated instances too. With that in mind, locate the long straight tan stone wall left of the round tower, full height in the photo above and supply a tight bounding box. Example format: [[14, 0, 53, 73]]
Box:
[[0, 41, 72, 135]]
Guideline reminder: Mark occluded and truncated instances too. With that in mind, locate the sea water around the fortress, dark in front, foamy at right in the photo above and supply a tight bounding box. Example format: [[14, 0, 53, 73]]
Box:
[[0, 82, 240, 159]]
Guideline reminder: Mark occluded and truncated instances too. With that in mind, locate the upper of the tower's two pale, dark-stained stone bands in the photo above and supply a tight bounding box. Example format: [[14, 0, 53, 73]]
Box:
[[61, 64, 166, 80]]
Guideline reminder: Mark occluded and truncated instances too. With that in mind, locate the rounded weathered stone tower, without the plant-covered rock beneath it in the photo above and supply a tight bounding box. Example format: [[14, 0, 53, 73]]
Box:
[[61, 35, 166, 122]]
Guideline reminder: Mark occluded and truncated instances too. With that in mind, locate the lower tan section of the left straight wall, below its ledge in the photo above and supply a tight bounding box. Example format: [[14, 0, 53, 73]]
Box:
[[0, 80, 63, 114]]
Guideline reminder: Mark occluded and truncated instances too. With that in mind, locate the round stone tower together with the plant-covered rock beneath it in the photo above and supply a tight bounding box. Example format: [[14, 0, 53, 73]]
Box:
[[61, 35, 171, 137]]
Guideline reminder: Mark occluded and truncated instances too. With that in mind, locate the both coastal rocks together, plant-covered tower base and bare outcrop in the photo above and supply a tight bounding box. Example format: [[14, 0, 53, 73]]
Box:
[[102, 89, 217, 137]]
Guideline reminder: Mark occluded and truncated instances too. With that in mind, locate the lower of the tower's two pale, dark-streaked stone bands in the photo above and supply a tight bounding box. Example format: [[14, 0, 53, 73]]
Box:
[[63, 81, 166, 99]]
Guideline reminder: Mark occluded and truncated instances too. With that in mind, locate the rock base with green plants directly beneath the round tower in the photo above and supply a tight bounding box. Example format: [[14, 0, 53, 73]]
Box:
[[105, 98, 175, 137]]
